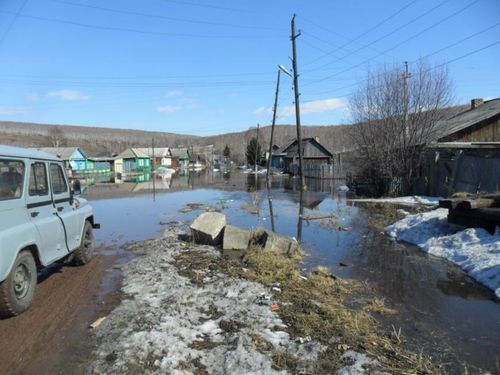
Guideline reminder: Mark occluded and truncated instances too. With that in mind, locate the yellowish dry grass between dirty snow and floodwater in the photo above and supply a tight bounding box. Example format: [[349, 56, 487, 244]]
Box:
[[240, 250, 443, 374]]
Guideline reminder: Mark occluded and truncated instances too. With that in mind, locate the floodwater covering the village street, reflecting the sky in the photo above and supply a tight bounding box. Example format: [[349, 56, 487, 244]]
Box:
[[86, 171, 500, 373]]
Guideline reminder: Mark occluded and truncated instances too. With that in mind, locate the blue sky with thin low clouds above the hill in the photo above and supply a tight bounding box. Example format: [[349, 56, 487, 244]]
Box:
[[0, 0, 500, 135]]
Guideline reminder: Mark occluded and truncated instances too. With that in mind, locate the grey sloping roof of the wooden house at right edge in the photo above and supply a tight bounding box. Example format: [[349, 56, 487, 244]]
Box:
[[436, 98, 500, 139]]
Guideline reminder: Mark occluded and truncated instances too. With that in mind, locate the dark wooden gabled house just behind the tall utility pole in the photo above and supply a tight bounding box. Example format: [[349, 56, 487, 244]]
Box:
[[282, 137, 333, 178]]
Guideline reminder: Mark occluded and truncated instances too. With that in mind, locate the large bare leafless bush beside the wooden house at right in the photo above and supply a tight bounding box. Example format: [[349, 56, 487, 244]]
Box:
[[349, 61, 451, 194]]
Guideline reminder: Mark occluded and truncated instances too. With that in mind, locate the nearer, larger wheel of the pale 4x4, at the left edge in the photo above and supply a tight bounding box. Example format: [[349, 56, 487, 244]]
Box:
[[0, 250, 37, 318]]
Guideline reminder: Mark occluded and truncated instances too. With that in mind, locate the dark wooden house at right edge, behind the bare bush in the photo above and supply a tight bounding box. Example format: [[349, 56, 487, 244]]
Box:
[[424, 98, 500, 197]]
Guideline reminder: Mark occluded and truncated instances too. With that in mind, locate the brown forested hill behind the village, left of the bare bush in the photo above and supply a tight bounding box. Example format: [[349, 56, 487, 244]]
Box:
[[0, 121, 347, 160]]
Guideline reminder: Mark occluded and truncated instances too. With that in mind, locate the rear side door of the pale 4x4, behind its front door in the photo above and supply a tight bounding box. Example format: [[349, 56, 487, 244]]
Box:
[[26, 161, 68, 265]]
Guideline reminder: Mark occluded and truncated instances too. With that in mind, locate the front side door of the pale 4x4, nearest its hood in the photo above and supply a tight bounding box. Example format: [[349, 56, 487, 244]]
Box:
[[50, 163, 83, 251]]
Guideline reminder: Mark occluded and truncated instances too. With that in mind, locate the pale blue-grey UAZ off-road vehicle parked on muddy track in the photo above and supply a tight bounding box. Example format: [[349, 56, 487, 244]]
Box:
[[0, 145, 99, 317]]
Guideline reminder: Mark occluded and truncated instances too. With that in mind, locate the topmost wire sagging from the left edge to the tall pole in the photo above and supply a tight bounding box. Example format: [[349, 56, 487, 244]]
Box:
[[0, 10, 284, 39]]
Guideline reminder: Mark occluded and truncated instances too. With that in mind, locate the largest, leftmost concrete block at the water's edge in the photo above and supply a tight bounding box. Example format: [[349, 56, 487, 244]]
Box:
[[190, 212, 226, 245]]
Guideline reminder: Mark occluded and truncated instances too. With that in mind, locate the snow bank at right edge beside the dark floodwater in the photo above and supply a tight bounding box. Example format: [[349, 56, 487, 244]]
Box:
[[385, 208, 500, 298]]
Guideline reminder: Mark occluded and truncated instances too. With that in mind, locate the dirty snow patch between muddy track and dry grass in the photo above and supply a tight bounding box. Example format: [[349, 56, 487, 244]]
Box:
[[88, 225, 326, 374]]
